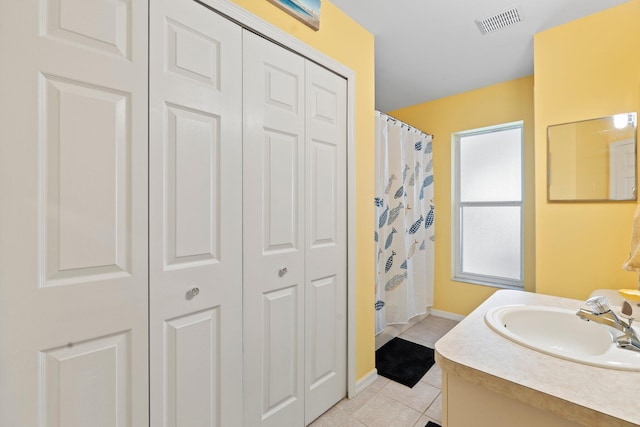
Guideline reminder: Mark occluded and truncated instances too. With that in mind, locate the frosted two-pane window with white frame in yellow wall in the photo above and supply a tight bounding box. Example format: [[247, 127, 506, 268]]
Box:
[[452, 122, 524, 288]]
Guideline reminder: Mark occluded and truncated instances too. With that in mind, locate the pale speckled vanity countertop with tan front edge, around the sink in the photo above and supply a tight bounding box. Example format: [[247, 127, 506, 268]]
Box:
[[435, 290, 640, 427]]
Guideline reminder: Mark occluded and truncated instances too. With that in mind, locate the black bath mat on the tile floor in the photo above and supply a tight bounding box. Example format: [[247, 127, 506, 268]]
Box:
[[376, 338, 435, 387]]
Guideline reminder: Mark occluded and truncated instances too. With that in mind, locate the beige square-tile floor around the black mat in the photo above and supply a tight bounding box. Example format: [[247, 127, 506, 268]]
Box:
[[310, 316, 457, 427]]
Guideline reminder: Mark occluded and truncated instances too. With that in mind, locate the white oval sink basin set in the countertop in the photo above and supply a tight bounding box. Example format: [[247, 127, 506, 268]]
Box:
[[485, 305, 640, 371]]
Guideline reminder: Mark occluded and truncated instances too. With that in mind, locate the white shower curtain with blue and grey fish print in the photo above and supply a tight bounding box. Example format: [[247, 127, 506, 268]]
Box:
[[374, 112, 435, 334]]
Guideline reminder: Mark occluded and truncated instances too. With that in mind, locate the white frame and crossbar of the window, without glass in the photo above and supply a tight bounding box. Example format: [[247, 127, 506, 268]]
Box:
[[451, 120, 525, 289]]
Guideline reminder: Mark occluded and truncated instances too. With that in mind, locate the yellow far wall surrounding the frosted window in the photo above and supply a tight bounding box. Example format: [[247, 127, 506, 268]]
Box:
[[390, 76, 534, 315]]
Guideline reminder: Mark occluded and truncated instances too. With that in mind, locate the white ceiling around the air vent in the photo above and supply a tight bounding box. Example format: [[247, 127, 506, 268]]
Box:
[[330, 0, 628, 111]]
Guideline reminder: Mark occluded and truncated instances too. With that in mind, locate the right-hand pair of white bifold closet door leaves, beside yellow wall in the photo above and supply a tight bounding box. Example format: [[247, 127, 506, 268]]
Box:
[[243, 31, 347, 427]]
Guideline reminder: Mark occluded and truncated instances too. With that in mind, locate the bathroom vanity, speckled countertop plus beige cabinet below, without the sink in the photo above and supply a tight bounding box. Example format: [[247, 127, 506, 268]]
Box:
[[435, 290, 640, 427]]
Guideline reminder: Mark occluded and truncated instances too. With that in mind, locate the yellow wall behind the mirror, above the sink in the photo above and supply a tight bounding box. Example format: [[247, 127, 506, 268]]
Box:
[[534, 0, 640, 299]]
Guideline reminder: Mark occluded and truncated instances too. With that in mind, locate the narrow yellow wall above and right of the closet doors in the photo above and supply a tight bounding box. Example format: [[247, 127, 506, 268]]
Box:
[[232, 0, 375, 379]]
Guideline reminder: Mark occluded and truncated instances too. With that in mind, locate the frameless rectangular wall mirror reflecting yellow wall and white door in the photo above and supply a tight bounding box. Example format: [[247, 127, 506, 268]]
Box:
[[547, 113, 637, 201]]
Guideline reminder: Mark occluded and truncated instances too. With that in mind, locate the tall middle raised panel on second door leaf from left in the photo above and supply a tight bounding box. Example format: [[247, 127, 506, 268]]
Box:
[[164, 104, 222, 267]]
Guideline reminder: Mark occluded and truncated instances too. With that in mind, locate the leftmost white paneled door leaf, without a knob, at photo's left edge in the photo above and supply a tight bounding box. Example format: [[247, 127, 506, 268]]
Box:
[[0, 0, 149, 427]]
